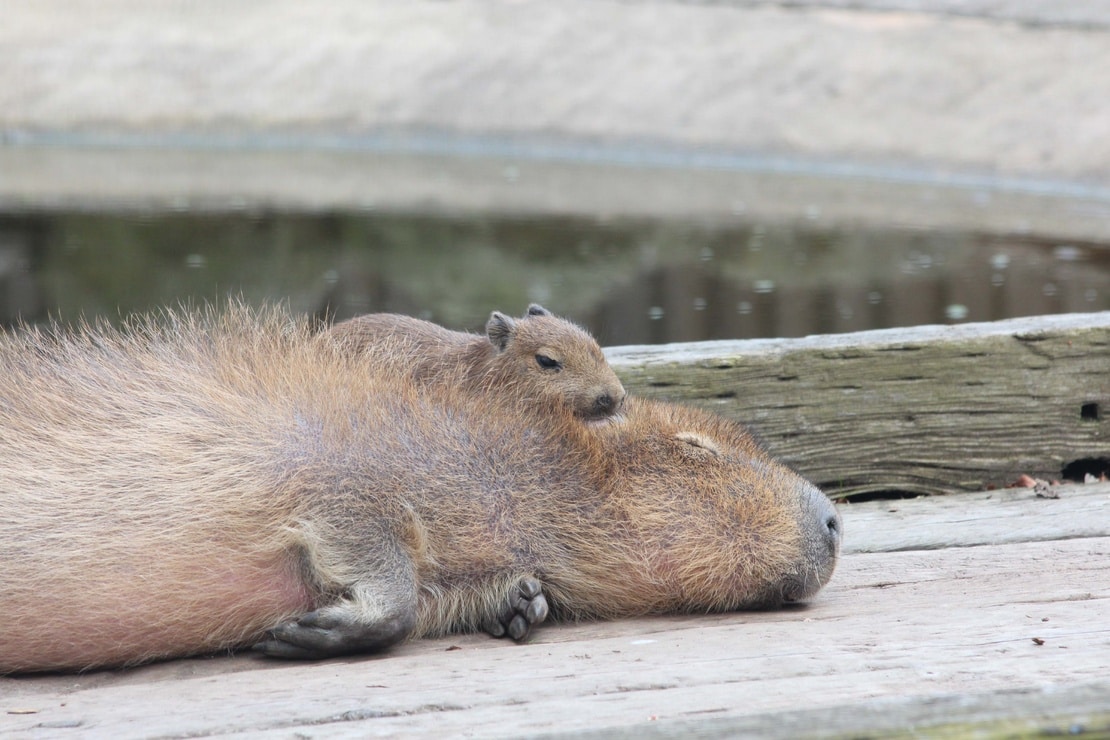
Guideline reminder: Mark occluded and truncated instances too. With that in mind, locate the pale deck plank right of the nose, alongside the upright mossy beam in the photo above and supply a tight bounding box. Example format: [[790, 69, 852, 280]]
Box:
[[840, 483, 1110, 553]]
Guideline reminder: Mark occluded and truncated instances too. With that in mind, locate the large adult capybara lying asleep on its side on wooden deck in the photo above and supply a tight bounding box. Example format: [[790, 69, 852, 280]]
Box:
[[0, 306, 840, 672]]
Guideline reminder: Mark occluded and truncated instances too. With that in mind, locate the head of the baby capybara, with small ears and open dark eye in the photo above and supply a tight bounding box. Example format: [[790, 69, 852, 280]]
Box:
[[486, 303, 625, 419]]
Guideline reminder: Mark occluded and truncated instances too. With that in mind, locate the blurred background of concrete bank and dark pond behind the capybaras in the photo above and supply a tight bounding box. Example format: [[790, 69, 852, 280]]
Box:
[[0, 0, 1110, 345]]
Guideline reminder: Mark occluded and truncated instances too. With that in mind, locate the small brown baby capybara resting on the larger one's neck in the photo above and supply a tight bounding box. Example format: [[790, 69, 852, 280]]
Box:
[[331, 303, 625, 420]]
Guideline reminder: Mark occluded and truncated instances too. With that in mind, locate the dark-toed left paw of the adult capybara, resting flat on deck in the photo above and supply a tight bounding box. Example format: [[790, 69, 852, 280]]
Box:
[[253, 607, 414, 660]]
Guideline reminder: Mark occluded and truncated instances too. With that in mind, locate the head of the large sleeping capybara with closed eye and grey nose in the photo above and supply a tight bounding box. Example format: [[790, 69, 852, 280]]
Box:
[[546, 397, 841, 617]]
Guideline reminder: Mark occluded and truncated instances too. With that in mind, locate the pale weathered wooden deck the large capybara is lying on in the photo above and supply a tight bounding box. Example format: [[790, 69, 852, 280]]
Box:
[[0, 484, 1110, 738]]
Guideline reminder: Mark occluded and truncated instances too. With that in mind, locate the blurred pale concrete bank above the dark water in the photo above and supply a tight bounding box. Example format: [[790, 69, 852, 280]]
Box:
[[0, 0, 1110, 240]]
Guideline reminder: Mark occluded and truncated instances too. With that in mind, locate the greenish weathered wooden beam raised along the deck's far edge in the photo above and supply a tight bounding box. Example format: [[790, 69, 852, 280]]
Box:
[[606, 312, 1110, 495]]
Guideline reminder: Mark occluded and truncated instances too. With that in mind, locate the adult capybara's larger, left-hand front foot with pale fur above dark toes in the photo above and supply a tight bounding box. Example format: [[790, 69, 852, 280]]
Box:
[[254, 587, 416, 660]]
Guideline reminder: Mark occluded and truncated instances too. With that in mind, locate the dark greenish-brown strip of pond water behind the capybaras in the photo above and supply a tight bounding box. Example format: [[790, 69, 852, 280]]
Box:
[[0, 213, 1110, 345]]
